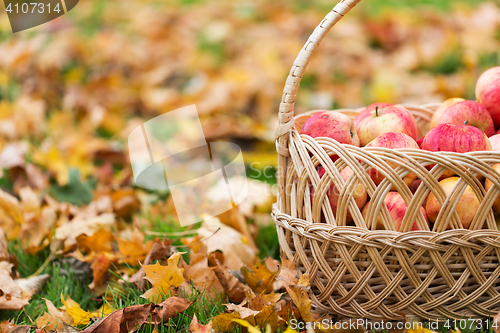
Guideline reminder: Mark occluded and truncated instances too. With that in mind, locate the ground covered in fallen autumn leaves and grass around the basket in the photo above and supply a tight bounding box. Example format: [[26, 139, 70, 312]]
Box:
[[0, 0, 500, 333]]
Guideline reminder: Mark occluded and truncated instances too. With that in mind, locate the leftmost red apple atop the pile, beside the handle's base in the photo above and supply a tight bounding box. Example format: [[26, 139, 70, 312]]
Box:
[[301, 111, 359, 147]]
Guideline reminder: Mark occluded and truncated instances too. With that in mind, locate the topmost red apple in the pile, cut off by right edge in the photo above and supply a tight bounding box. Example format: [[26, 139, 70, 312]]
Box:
[[476, 66, 500, 127]]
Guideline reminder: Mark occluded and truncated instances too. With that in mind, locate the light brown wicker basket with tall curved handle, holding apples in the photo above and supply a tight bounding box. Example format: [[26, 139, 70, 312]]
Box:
[[273, 0, 500, 320]]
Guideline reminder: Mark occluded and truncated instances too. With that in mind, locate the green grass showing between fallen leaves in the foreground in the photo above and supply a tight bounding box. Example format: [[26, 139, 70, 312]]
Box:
[[0, 210, 279, 333]]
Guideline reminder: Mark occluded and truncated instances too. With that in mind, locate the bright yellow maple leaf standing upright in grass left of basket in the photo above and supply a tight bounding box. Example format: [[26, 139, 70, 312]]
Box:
[[141, 252, 184, 302]]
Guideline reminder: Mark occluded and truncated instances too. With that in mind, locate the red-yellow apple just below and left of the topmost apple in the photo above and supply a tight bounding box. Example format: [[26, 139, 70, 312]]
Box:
[[438, 101, 495, 136]]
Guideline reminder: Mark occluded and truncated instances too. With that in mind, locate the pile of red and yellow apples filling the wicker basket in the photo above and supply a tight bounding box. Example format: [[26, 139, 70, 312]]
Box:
[[301, 67, 500, 231]]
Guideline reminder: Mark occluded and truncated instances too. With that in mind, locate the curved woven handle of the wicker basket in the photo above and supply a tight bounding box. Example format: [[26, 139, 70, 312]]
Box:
[[276, 0, 361, 139]]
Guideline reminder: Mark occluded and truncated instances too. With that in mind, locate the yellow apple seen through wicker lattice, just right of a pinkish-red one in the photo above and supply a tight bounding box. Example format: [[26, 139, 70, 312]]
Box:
[[425, 177, 480, 229]]
